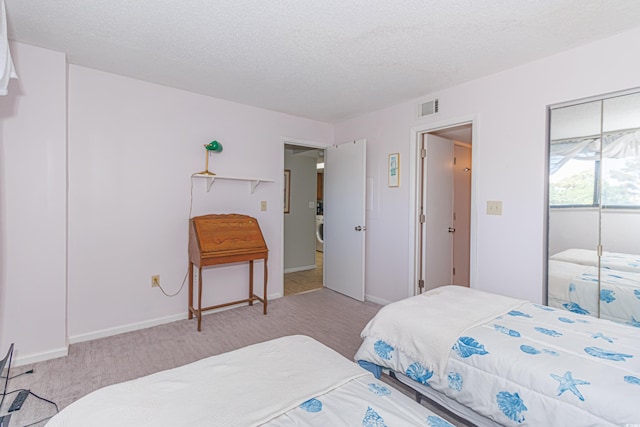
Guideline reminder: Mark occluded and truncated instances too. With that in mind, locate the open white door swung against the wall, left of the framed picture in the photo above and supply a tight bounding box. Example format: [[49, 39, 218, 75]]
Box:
[[323, 139, 367, 301]]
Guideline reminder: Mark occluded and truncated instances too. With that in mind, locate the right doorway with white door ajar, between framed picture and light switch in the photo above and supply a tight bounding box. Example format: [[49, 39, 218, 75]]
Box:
[[411, 121, 475, 294]]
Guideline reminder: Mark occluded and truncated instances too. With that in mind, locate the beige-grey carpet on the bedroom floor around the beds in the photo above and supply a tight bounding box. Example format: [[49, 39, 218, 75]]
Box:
[[0, 289, 470, 427]]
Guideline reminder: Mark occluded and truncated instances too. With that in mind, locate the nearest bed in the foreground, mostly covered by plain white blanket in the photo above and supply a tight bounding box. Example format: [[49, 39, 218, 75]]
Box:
[[47, 335, 451, 427]]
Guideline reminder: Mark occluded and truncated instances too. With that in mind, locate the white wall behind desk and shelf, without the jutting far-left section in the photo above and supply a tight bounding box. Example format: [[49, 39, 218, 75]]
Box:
[[69, 66, 332, 339]]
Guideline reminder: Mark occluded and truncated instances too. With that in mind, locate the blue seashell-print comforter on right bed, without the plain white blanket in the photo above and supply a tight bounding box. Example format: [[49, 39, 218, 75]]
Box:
[[355, 288, 640, 426]]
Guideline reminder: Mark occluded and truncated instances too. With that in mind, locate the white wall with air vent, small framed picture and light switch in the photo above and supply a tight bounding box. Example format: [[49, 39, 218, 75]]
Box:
[[335, 25, 640, 302]]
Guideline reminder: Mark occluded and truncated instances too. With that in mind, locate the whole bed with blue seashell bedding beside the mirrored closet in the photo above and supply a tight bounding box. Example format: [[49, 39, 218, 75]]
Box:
[[355, 286, 640, 426]]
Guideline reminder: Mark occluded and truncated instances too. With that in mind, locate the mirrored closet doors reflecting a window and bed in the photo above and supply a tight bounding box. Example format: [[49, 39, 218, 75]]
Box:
[[547, 89, 640, 327]]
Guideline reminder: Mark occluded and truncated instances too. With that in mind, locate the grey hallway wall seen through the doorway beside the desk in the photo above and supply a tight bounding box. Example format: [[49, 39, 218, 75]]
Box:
[[284, 150, 318, 272]]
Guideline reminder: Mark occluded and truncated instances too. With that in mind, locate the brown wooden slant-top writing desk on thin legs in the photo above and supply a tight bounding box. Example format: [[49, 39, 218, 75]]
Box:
[[189, 214, 269, 331]]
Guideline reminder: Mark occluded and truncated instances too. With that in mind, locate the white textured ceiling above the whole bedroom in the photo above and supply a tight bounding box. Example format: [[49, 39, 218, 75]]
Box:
[[5, 0, 640, 122]]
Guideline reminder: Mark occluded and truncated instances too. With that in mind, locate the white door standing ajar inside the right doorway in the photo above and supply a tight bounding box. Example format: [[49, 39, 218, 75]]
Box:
[[423, 134, 454, 291]]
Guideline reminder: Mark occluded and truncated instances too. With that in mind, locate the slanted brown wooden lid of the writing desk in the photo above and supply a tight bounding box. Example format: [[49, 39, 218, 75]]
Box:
[[192, 214, 267, 254]]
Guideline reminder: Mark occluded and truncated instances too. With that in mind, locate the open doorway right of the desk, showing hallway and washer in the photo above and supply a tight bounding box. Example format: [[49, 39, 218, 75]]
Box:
[[283, 143, 325, 296]]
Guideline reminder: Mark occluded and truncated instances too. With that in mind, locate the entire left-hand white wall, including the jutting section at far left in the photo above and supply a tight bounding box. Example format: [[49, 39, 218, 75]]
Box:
[[0, 44, 332, 363]]
